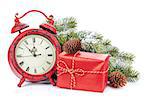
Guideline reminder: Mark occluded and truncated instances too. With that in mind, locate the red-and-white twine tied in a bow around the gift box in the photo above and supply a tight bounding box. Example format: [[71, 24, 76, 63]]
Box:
[[57, 51, 109, 89]]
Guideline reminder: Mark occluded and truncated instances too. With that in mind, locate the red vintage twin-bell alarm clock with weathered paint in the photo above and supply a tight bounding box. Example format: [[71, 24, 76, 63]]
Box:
[[8, 10, 61, 87]]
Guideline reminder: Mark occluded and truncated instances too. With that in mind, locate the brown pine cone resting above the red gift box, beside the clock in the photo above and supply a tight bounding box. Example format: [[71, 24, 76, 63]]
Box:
[[63, 39, 81, 54]]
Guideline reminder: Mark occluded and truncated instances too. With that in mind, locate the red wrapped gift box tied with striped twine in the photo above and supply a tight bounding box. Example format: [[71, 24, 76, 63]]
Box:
[[56, 52, 109, 92]]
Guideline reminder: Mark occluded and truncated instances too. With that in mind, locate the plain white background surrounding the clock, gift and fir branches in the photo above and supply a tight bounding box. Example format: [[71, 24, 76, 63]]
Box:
[[0, 0, 150, 99]]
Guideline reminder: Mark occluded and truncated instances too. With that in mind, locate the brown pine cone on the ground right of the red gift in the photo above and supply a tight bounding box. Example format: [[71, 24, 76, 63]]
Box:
[[109, 71, 127, 88]]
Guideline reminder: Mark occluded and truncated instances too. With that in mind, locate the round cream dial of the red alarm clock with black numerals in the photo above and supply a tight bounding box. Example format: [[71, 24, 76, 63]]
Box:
[[15, 35, 56, 75]]
